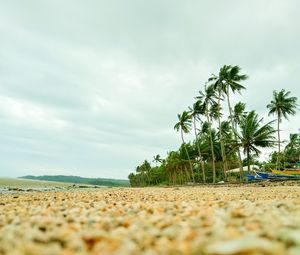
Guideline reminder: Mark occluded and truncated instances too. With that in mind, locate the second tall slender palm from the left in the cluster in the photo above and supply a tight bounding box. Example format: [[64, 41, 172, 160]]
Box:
[[189, 100, 206, 183]]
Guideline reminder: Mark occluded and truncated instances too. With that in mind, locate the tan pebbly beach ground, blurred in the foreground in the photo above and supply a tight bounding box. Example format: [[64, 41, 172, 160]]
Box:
[[0, 186, 300, 255]]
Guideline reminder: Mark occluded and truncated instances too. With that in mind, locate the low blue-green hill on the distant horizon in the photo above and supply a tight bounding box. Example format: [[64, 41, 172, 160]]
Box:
[[18, 175, 130, 187]]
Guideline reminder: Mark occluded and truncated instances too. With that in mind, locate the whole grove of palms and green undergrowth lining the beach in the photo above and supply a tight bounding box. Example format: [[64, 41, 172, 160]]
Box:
[[131, 65, 297, 186]]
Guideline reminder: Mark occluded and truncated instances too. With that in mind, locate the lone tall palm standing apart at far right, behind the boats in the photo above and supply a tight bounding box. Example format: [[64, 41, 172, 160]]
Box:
[[267, 89, 297, 169]]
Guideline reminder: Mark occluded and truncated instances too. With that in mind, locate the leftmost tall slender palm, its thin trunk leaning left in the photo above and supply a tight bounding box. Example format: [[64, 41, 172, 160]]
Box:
[[174, 111, 195, 182]]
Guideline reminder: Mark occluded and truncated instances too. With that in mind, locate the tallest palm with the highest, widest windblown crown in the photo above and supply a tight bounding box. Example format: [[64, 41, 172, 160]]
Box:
[[215, 65, 248, 179]]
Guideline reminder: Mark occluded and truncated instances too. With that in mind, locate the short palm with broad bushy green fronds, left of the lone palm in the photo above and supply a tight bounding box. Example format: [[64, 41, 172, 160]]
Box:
[[238, 111, 276, 171]]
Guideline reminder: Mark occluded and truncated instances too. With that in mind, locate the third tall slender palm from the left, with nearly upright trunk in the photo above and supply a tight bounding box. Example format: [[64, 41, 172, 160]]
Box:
[[196, 85, 216, 183]]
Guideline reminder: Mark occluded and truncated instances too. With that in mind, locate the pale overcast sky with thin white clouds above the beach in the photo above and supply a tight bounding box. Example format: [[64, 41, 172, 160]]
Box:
[[0, 0, 300, 179]]
